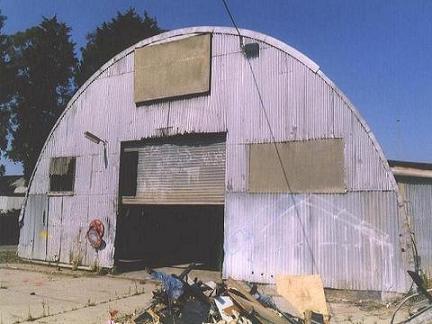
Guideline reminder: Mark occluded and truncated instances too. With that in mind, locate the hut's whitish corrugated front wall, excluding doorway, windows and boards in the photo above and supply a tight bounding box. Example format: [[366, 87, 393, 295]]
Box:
[[19, 27, 407, 291]]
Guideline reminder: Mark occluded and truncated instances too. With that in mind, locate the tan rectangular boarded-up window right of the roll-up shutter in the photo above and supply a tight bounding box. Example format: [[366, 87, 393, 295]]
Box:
[[249, 139, 346, 193]]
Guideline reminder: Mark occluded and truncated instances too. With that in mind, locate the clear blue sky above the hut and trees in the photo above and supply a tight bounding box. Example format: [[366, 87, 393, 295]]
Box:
[[0, 0, 432, 174]]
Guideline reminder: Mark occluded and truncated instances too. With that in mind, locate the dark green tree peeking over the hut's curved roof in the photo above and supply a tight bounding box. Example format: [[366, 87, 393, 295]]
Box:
[[76, 9, 164, 86]]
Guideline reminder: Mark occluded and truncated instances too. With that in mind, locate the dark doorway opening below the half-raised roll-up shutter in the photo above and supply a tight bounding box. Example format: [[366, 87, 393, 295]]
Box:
[[115, 205, 224, 270]]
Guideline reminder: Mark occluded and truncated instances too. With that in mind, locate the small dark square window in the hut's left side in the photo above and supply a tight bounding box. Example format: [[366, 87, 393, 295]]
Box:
[[50, 157, 75, 192]]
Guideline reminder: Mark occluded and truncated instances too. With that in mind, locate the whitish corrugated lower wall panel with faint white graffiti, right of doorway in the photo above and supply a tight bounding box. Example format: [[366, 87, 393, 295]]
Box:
[[223, 192, 410, 292]]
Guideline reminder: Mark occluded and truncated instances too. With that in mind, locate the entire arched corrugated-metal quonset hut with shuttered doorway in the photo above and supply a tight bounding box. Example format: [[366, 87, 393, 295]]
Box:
[[18, 27, 412, 292]]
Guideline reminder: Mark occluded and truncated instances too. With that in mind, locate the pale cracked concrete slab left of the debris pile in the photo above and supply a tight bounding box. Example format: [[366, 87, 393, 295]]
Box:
[[0, 268, 156, 323]]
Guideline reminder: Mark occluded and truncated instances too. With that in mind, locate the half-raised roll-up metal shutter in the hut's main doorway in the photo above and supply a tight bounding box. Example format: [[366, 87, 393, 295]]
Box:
[[124, 136, 225, 205]]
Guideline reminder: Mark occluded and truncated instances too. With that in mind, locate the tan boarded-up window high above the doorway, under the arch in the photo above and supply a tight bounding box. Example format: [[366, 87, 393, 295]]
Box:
[[135, 34, 211, 103]]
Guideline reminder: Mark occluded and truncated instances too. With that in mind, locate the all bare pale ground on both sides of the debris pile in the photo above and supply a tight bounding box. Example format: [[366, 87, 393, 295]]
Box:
[[0, 249, 416, 324]]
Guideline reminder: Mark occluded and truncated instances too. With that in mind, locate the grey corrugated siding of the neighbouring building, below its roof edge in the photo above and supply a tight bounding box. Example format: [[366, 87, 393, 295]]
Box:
[[398, 178, 432, 277]]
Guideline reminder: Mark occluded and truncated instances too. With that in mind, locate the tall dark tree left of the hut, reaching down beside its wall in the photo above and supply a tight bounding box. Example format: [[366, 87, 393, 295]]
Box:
[[7, 16, 77, 180]]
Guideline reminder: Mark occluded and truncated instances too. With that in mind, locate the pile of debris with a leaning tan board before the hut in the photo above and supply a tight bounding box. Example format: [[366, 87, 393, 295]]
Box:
[[135, 264, 330, 324]]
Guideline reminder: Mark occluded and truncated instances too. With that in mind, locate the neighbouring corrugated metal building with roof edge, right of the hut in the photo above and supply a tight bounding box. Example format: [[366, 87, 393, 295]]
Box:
[[389, 161, 432, 278]]
